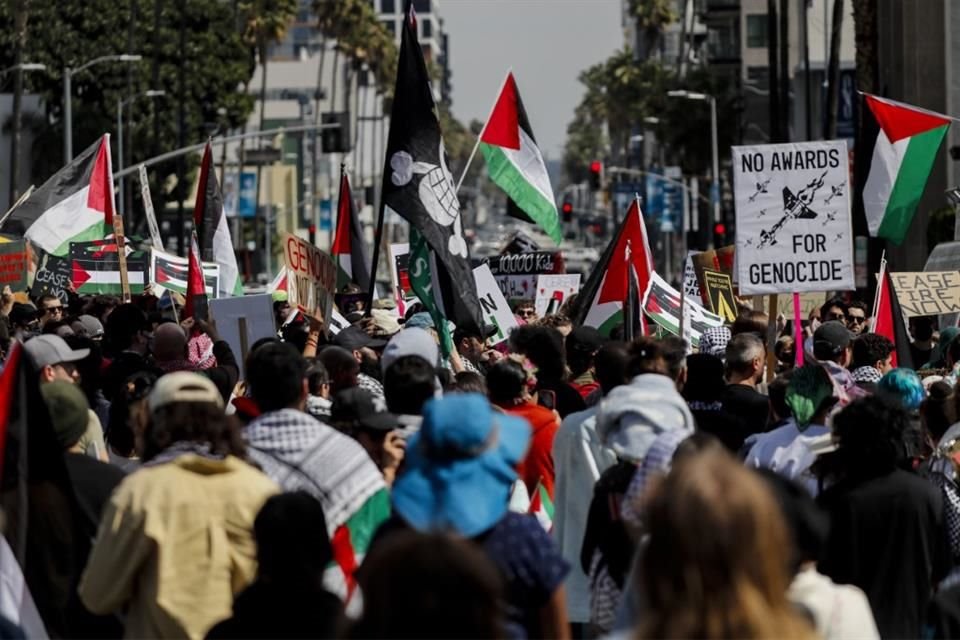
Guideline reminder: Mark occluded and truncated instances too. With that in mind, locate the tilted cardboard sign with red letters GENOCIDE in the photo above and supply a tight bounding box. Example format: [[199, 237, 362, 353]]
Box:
[[282, 233, 337, 322]]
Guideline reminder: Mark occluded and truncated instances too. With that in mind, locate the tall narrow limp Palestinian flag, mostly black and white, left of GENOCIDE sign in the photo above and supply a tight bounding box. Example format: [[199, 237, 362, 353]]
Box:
[[193, 142, 243, 298]]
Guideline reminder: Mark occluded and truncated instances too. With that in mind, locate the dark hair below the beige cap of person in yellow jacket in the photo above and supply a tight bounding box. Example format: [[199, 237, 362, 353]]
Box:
[[140, 402, 247, 462]]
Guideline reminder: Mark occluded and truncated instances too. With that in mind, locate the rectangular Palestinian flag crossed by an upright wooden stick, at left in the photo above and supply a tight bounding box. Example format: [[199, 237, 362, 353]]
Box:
[[70, 239, 150, 295]]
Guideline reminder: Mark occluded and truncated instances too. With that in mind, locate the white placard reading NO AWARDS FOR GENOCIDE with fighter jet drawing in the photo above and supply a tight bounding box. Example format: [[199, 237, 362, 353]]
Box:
[[733, 140, 854, 295]]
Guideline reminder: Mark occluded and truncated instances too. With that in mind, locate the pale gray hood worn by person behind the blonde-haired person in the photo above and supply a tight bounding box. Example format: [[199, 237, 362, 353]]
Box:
[[597, 373, 695, 464]]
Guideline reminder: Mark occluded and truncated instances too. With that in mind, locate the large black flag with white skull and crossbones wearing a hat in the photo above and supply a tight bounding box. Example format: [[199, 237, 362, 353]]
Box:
[[382, 0, 482, 331]]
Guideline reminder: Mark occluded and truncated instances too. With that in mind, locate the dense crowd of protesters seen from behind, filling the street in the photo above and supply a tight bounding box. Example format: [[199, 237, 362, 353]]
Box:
[[0, 282, 960, 638]]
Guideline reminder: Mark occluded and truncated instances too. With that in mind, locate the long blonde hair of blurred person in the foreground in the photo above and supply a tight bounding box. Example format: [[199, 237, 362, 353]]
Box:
[[638, 450, 814, 638]]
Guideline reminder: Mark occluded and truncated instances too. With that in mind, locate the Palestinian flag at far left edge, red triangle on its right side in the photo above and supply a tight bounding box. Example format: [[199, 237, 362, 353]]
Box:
[[0, 134, 115, 257]]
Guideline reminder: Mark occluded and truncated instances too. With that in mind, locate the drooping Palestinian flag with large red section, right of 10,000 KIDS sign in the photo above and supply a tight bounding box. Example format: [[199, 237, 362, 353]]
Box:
[[574, 200, 653, 336]]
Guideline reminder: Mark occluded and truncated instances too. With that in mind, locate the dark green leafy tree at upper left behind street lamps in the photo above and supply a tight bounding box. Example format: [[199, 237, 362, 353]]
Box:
[[0, 0, 253, 212]]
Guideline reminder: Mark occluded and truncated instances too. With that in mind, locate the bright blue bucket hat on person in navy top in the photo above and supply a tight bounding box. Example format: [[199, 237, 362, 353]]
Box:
[[392, 393, 530, 538]]
